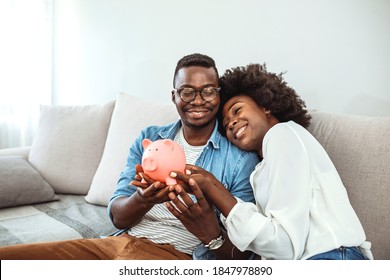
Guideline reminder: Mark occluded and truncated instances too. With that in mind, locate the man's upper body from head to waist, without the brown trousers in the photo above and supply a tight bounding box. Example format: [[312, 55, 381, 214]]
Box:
[[109, 54, 258, 259]]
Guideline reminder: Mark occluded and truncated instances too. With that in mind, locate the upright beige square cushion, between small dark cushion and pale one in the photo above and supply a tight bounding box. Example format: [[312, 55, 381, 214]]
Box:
[[29, 101, 114, 194]]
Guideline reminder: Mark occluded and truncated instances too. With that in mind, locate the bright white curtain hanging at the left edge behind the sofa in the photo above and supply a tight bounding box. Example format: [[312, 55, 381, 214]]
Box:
[[0, 0, 52, 149]]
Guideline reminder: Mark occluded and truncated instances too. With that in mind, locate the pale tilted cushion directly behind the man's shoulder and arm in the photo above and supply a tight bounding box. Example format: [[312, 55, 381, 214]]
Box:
[[85, 93, 179, 206]]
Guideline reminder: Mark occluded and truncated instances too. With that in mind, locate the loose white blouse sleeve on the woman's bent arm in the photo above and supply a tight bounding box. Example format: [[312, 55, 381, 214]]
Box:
[[224, 124, 311, 259]]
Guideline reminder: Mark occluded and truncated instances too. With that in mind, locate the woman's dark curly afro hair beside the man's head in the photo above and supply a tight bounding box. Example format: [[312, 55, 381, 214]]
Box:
[[219, 64, 311, 128]]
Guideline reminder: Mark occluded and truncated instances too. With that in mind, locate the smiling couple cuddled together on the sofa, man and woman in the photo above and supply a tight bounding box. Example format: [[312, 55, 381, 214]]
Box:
[[0, 54, 372, 260]]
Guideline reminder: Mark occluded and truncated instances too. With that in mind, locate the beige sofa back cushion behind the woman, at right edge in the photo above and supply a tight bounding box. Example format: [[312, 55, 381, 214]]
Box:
[[309, 111, 390, 259]]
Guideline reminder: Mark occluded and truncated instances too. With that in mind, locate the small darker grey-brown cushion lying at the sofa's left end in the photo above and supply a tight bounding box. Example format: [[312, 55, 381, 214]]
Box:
[[0, 156, 57, 208]]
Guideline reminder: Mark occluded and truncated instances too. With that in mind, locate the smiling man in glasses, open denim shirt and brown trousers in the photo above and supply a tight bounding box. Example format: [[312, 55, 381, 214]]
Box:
[[0, 54, 258, 259]]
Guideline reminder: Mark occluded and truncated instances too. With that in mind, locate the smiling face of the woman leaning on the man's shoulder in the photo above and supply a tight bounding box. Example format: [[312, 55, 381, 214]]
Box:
[[222, 95, 278, 156]]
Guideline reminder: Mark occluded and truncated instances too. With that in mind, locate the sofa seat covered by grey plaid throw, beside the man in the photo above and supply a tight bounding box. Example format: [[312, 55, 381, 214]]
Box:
[[0, 194, 116, 246]]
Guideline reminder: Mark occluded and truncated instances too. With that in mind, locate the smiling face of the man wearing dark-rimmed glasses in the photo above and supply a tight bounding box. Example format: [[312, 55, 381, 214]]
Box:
[[172, 66, 220, 129]]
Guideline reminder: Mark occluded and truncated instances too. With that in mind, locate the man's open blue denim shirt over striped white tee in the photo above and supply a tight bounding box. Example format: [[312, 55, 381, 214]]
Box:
[[107, 120, 259, 259]]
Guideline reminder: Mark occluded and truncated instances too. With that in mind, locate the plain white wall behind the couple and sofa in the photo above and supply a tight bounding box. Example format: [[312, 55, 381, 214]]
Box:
[[53, 0, 390, 116]]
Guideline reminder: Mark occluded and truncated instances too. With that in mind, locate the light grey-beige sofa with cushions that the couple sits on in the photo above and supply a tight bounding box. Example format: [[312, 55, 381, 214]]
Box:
[[0, 94, 390, 259]]
